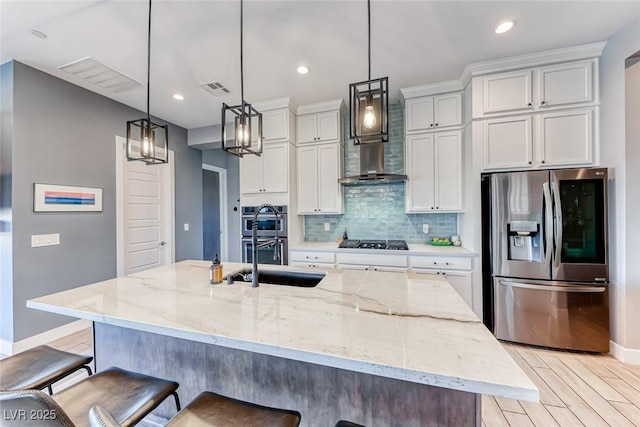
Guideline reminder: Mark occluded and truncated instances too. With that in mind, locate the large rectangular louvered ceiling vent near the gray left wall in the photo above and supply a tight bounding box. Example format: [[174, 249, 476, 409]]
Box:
[[58, 57, 142, 93]]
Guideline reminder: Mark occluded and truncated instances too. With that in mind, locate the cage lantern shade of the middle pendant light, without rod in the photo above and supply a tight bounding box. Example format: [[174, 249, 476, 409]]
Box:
[[222, 102, 262, 157]]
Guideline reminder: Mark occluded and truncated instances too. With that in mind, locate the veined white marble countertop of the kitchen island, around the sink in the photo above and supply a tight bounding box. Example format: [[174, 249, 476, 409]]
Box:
[[27, 261, 539, 401]]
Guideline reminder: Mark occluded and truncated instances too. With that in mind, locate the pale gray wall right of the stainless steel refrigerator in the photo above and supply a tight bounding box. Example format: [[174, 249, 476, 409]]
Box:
[[600, 14, 640, 350]]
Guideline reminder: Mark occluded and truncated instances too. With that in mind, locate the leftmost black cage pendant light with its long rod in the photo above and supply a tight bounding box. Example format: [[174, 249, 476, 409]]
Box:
[[126, 0, 169, 165]]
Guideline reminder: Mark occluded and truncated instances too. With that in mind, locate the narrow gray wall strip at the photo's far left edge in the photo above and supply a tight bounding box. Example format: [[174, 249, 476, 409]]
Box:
[[0, 62, 13, 341]]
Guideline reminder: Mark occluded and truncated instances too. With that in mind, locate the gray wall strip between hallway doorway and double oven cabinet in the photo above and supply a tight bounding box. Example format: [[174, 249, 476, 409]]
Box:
[[201, 149, 242, 262]]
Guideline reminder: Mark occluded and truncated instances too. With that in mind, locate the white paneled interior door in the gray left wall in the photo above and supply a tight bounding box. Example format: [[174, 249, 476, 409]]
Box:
[[116, 137, 175, 276]]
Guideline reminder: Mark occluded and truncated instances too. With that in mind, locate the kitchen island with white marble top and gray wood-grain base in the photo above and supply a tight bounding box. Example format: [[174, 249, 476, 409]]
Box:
[[27, 261, 539, 426]]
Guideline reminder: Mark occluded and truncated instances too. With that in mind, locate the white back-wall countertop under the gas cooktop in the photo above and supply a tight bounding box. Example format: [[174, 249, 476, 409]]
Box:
[[289, 242, 475, 257]]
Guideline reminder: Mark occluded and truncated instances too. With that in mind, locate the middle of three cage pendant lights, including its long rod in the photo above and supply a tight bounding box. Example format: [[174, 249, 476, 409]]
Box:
[[222, 0, 262, 157]]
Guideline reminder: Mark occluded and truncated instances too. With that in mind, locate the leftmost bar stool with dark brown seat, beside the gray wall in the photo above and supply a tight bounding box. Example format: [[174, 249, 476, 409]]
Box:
[[0, 345, 93, 394]]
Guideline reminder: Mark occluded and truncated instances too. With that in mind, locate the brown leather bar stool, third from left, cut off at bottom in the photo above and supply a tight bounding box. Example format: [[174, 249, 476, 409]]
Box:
[[89, 391, 301, 427]]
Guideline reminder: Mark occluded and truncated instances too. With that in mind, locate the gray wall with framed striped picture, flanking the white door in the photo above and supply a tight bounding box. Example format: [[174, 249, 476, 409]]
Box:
[[1, 62, 202, 342]]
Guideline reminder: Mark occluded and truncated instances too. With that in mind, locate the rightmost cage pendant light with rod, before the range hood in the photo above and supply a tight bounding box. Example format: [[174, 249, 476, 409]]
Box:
[[349, 0, 389, 145]]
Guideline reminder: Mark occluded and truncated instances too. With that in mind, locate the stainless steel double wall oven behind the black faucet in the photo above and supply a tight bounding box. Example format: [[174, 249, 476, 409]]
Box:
[[242, 206, 289, 265]]
